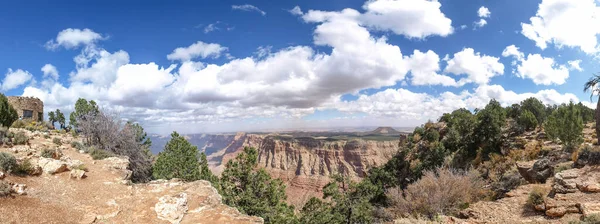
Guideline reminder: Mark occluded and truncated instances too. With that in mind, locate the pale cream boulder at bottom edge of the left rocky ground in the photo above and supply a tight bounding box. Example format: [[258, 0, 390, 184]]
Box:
[[154, 193, 188, 223]]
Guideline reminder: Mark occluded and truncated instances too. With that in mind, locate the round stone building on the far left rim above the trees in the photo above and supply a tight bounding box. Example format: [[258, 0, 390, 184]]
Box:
[[7, 96, 44, 121]]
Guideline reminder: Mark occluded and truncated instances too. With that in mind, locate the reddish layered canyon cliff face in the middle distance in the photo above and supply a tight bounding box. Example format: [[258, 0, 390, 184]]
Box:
[[209, 133, 399, 207]]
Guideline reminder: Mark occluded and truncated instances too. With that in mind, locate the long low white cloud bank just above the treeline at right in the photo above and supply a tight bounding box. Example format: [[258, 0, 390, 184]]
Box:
[[332, 85, 579, 121]]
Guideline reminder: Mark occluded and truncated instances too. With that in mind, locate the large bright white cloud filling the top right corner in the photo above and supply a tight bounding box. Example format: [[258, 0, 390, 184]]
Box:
[[521, 0, 600, 54]]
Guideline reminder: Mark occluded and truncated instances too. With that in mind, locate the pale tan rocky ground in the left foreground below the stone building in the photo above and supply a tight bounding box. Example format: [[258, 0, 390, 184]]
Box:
[[0, 131, 263, 223]]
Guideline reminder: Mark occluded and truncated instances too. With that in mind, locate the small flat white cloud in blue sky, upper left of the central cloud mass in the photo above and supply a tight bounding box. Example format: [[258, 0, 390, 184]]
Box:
[[167, 41, 227, 61]]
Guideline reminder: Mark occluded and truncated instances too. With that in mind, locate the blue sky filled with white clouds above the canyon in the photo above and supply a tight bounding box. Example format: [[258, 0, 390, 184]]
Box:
[[0, 0, 600, 134]]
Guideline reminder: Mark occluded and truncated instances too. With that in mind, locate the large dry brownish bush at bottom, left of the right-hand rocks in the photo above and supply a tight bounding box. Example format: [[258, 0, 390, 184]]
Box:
[[388, 168, 485, 218]]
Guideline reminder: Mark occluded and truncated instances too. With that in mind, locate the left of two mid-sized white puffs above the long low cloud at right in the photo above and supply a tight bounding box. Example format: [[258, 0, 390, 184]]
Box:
[[444, 48, 504, 85]]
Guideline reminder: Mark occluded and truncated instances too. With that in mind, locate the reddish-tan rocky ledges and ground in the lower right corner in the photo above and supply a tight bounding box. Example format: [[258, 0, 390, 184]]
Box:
[[452, 124, 600, 223]]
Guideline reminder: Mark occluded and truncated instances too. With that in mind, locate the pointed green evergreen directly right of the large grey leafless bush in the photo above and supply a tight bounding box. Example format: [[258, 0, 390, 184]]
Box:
[[152, 132, 201, 181]]
